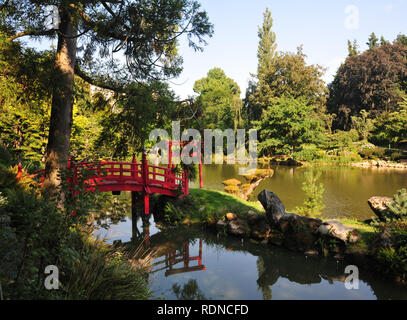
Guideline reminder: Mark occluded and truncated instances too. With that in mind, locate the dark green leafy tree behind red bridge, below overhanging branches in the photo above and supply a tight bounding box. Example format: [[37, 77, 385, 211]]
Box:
[[95, 81, 177, 159]]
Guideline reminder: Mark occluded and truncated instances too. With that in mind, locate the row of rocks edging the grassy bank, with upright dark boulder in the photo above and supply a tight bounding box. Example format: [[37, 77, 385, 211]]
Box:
[[216, 190, 361, 259]]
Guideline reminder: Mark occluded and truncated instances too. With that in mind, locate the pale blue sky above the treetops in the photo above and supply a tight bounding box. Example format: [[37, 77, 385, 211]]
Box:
[[171, 0, 407, 98]]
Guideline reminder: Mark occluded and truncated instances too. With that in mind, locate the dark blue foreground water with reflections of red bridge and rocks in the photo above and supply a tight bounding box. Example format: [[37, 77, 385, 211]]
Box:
[[112, 216, 407, 300]]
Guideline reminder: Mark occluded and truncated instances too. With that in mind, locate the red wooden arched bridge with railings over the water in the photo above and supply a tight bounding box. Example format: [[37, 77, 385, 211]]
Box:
[[17, 141, 202, 214]]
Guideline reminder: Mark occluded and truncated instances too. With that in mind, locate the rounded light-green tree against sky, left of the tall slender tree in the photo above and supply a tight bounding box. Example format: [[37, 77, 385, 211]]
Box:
[[194, 68, 242, 130]]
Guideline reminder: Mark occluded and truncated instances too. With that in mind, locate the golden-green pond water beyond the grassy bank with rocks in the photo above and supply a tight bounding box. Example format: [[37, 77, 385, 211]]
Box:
[[191, 165, 407, 220]]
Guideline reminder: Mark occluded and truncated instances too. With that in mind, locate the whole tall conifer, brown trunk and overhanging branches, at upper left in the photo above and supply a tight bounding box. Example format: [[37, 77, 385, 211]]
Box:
[[0, 0, 213, 187]]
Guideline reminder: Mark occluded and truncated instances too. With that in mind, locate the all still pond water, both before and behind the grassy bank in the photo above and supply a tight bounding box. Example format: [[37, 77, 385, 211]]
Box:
[[96, 166, 407, 300]]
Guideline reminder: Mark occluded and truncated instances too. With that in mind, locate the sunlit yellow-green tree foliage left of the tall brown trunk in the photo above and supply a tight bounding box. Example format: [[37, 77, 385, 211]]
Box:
[[0, 31, 54, 162]]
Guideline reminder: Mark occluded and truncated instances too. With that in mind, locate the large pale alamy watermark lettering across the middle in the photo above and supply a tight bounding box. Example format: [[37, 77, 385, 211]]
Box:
[[148, 121, 258, 175]]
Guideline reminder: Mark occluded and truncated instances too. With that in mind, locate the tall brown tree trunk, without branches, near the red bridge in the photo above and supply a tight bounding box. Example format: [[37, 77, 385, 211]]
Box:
[[44, 9, 77, 192]]
